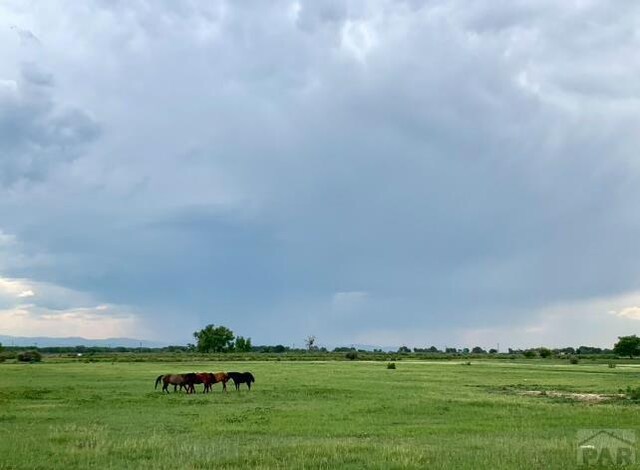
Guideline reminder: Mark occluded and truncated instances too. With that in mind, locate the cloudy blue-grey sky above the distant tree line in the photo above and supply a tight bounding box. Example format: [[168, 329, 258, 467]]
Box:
[[0, 0, 640, 349]]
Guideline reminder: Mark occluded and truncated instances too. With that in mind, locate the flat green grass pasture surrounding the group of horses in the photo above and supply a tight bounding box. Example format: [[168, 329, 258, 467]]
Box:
[[0, 361, 640, 469]]
